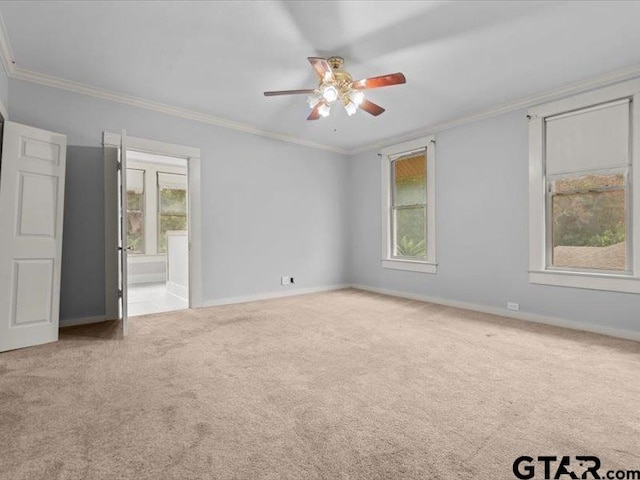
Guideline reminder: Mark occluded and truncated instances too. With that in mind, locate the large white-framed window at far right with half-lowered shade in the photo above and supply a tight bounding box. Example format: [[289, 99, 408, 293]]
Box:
[[529, 82, 640, 293]]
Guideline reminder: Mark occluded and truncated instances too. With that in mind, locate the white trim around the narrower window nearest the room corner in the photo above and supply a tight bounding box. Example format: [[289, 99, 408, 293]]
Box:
[[380, 135, 438, 273]]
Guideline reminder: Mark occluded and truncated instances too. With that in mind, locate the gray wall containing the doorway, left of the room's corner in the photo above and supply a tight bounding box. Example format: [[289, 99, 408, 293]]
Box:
[[9, 79, 348, 319]]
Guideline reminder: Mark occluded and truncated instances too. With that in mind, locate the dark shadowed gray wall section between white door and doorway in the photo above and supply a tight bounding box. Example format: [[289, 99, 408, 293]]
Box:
[[60, 146, 105, 320]]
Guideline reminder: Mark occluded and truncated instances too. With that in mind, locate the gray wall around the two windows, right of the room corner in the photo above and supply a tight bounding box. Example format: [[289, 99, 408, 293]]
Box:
[[349, 111, 640, 332]]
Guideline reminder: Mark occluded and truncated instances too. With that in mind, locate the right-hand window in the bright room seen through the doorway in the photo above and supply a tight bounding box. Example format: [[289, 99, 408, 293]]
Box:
[[158, 172, 187, 253]]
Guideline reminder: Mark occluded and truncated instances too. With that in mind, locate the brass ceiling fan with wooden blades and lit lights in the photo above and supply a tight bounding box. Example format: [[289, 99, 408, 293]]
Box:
[[264, 57, 407, 120]]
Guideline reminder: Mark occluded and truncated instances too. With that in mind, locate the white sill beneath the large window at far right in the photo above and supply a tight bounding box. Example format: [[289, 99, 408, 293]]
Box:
[[529, 270, 640, 293]]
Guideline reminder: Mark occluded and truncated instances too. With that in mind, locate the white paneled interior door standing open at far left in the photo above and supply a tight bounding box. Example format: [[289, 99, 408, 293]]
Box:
[[0, 122, 67, 351]]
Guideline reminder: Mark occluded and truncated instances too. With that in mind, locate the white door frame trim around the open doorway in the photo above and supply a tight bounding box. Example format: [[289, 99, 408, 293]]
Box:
[[102, 132, 202, 313]]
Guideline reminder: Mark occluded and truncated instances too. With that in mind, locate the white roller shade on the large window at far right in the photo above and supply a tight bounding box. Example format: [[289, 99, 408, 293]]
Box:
[[546, 99, 630, 175]]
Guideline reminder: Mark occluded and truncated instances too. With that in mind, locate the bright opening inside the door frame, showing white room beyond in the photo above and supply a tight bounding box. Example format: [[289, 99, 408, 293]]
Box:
[[126, 150, 189, 316]]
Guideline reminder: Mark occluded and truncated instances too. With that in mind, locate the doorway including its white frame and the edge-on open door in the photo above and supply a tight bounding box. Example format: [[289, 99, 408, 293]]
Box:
[[103, 131, 202, 335]]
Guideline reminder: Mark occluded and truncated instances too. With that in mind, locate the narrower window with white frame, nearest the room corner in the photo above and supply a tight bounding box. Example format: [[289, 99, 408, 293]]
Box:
[[381, 137, 436, 273]]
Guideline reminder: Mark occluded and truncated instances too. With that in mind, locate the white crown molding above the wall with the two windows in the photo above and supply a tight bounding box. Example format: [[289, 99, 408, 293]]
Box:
[[349, 65, 640, 155]]
